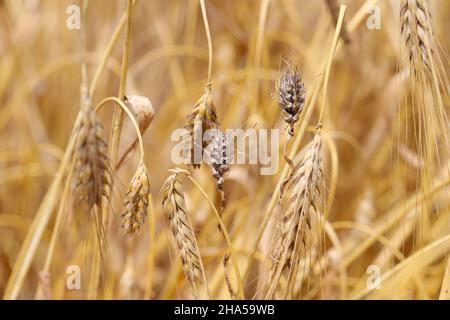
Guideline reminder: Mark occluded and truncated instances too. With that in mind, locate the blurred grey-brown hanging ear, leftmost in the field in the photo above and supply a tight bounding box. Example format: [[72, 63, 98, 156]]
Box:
[[72, 101, 111, 210]]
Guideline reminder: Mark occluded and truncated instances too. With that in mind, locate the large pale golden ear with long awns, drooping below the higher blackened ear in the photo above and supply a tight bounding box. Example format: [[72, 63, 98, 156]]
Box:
[[266, 127, 323, 299]]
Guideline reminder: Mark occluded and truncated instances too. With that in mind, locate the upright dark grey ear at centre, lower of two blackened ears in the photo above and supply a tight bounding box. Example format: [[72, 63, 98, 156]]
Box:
[[208, 131, 234, 212]]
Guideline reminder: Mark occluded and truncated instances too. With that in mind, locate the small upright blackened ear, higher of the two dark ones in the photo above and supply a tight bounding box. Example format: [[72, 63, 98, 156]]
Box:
[[277, 65, 305, 136]]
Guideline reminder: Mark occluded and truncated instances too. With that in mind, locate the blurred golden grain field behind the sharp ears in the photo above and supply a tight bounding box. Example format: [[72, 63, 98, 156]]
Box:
[[0, 0, 450, 299]]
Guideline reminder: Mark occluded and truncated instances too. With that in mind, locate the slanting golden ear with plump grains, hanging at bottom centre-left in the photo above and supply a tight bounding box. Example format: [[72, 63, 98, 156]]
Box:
[[162, 170, 206, 294]]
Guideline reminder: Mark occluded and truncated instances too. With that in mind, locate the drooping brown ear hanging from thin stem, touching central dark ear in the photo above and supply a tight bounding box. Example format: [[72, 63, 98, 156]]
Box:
[[184, 84, 219, 168]]
